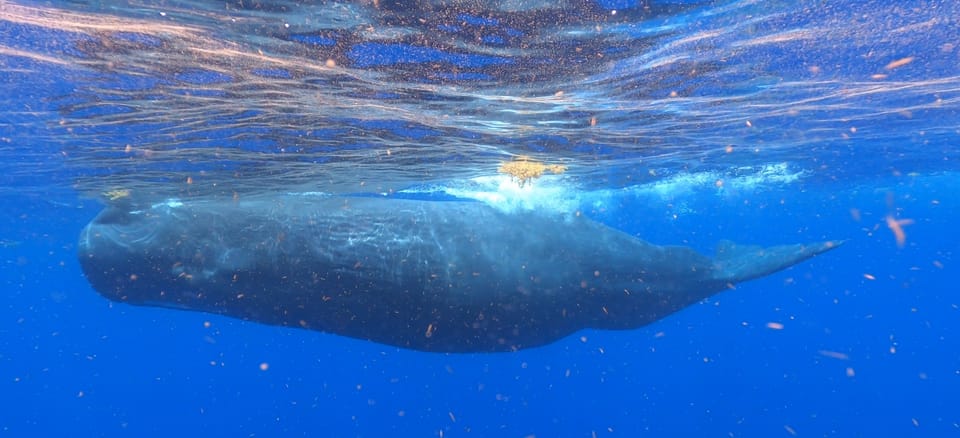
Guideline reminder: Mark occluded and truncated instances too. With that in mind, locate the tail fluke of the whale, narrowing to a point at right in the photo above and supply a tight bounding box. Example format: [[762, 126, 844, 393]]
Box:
[[714, 240, 843, 283]]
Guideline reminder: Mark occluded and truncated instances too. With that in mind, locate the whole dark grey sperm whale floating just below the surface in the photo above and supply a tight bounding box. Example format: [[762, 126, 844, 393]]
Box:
[[79, 195, 840, 352]]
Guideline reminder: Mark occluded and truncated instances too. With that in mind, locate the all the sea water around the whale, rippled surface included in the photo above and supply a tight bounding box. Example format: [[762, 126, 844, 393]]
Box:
[[0, 0, 960, 437]]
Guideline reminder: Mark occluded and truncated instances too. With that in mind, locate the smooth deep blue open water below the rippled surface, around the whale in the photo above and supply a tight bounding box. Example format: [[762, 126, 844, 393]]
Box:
[[0, 175, 960, 436]]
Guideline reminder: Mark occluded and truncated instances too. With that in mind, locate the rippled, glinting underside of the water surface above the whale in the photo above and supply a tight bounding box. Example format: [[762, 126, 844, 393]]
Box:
[[0, 1, 960, 202]]
